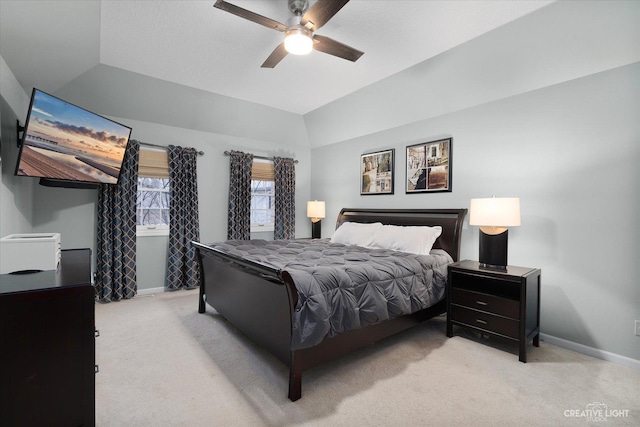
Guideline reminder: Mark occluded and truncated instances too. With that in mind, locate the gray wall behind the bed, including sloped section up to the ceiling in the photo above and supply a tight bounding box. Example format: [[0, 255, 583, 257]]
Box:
[[305, 2, 640, 360]]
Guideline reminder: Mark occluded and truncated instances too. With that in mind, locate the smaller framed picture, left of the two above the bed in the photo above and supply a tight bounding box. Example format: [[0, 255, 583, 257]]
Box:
[[360, 149, 395, 195]]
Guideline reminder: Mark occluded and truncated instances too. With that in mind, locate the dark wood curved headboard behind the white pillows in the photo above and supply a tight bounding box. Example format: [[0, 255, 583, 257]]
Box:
[[336, 208, 467, 261]]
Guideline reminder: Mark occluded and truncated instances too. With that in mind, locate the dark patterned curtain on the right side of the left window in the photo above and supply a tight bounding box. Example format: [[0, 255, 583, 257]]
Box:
[[166, 145, 200, 290]]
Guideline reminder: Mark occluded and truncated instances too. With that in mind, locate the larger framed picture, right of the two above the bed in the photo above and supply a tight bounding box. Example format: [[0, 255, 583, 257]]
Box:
[[405, 138, 453, 194]]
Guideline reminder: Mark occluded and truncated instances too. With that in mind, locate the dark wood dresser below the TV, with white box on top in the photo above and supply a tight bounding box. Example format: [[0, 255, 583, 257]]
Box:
[[0, 249, 96, 426]]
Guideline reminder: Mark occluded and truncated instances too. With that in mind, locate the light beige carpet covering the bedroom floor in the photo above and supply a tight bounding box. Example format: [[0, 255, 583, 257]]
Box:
[[96, 291, 640, 427]]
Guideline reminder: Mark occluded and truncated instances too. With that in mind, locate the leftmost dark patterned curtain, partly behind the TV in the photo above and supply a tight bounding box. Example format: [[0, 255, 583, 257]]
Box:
[[95, 140, 140, 302]]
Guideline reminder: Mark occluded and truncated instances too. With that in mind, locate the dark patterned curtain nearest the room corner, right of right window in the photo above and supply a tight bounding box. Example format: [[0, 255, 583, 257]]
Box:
[[273, 157, 296, 240]]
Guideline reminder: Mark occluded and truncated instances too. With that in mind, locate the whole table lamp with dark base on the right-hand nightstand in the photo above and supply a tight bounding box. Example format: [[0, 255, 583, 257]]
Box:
[[469, 197, 520, 271]]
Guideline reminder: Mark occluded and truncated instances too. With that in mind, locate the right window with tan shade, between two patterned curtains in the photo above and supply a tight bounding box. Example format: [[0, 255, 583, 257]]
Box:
[[251, 159, 276, 233]]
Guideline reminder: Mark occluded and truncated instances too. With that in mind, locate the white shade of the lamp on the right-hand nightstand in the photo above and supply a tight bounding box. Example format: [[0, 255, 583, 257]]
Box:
[[469, 197, 520, 227]]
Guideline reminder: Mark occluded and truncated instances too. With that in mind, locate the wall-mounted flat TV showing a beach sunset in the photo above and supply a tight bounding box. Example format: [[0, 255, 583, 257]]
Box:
[[16, 89, 131, 184]]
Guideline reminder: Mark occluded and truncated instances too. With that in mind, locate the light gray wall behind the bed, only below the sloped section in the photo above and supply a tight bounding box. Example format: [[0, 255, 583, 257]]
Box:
[[311, 63, 640, 359]]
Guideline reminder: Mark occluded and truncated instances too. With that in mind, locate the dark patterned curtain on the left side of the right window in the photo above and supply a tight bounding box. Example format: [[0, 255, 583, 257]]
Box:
[[227, 151, 253, 240]]
